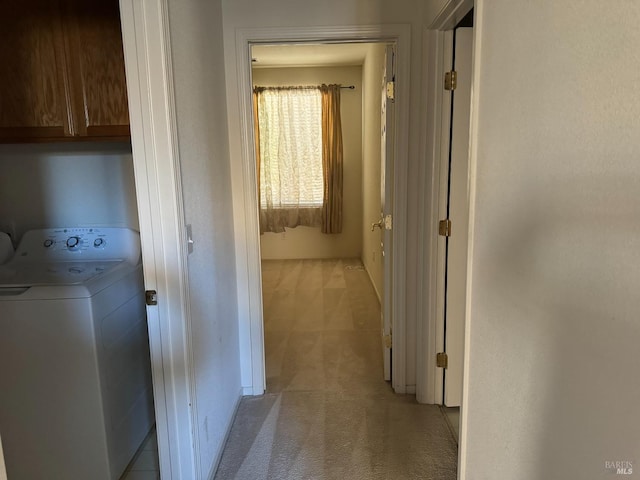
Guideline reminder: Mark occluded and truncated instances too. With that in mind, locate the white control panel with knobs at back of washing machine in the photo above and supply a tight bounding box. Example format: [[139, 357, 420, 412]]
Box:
[[13, 227, 140, 264]]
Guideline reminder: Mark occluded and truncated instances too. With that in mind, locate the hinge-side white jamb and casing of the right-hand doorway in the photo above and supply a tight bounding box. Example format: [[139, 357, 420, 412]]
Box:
[[416, 0, 477, 404]]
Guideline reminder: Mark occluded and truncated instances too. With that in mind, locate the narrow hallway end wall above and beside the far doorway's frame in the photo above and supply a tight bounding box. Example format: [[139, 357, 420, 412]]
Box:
[[223, 0, 424, 391]]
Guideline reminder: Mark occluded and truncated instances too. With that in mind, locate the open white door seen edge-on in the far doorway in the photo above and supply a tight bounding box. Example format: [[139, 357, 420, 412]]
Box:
[[378, 45, 395, 380]]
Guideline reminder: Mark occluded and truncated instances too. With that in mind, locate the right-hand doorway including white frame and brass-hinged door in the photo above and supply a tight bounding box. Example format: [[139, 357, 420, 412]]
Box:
[[416, 0, 474, 464]]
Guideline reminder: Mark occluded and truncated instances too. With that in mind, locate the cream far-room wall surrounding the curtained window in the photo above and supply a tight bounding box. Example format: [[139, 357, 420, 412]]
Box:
[[253, 66, 362, 259]]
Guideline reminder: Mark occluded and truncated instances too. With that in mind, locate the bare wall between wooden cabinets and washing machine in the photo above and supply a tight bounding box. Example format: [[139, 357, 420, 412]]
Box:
[[0, 142, 138, 241]]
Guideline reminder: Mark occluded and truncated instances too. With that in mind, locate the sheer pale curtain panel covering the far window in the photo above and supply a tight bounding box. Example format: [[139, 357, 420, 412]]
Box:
[[255, 87, 324, 236]]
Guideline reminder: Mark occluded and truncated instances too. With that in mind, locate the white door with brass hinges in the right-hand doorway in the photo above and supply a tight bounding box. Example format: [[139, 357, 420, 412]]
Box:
[[444, 28, 473, 407]]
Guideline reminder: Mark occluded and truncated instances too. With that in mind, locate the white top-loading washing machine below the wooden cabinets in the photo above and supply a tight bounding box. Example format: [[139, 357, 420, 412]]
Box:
[[0, 228, 154, 480]]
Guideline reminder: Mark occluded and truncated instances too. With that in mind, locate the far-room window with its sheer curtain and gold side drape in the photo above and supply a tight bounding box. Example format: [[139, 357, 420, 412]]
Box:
[[253, 84, 343, 233]]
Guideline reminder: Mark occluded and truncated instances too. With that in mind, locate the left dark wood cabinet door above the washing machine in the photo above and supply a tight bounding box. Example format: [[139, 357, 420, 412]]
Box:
[[0, 0, 72, 143]]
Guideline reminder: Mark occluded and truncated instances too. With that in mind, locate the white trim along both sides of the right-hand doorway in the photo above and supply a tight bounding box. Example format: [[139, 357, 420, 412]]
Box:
[[416, 0, 482, 474]]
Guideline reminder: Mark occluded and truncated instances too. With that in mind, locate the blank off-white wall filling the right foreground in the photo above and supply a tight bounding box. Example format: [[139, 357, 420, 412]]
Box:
[[462, 0, 640, 480]]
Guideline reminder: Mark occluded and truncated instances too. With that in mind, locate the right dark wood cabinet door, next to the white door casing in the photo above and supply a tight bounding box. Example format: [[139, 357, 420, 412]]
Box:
[[63, 0, 129, 137]]
